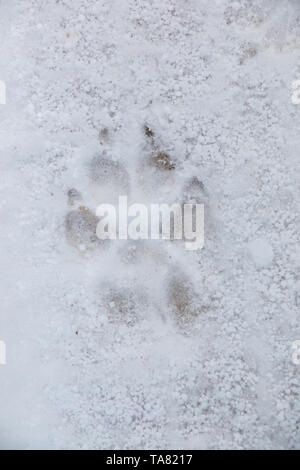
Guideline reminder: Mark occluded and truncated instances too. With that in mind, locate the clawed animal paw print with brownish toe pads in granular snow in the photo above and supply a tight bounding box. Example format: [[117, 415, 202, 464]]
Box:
[[65, 124, 208, 333]]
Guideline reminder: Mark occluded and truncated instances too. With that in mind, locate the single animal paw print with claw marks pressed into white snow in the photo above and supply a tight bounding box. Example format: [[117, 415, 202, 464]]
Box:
[[65, 125, 207, 332]]
